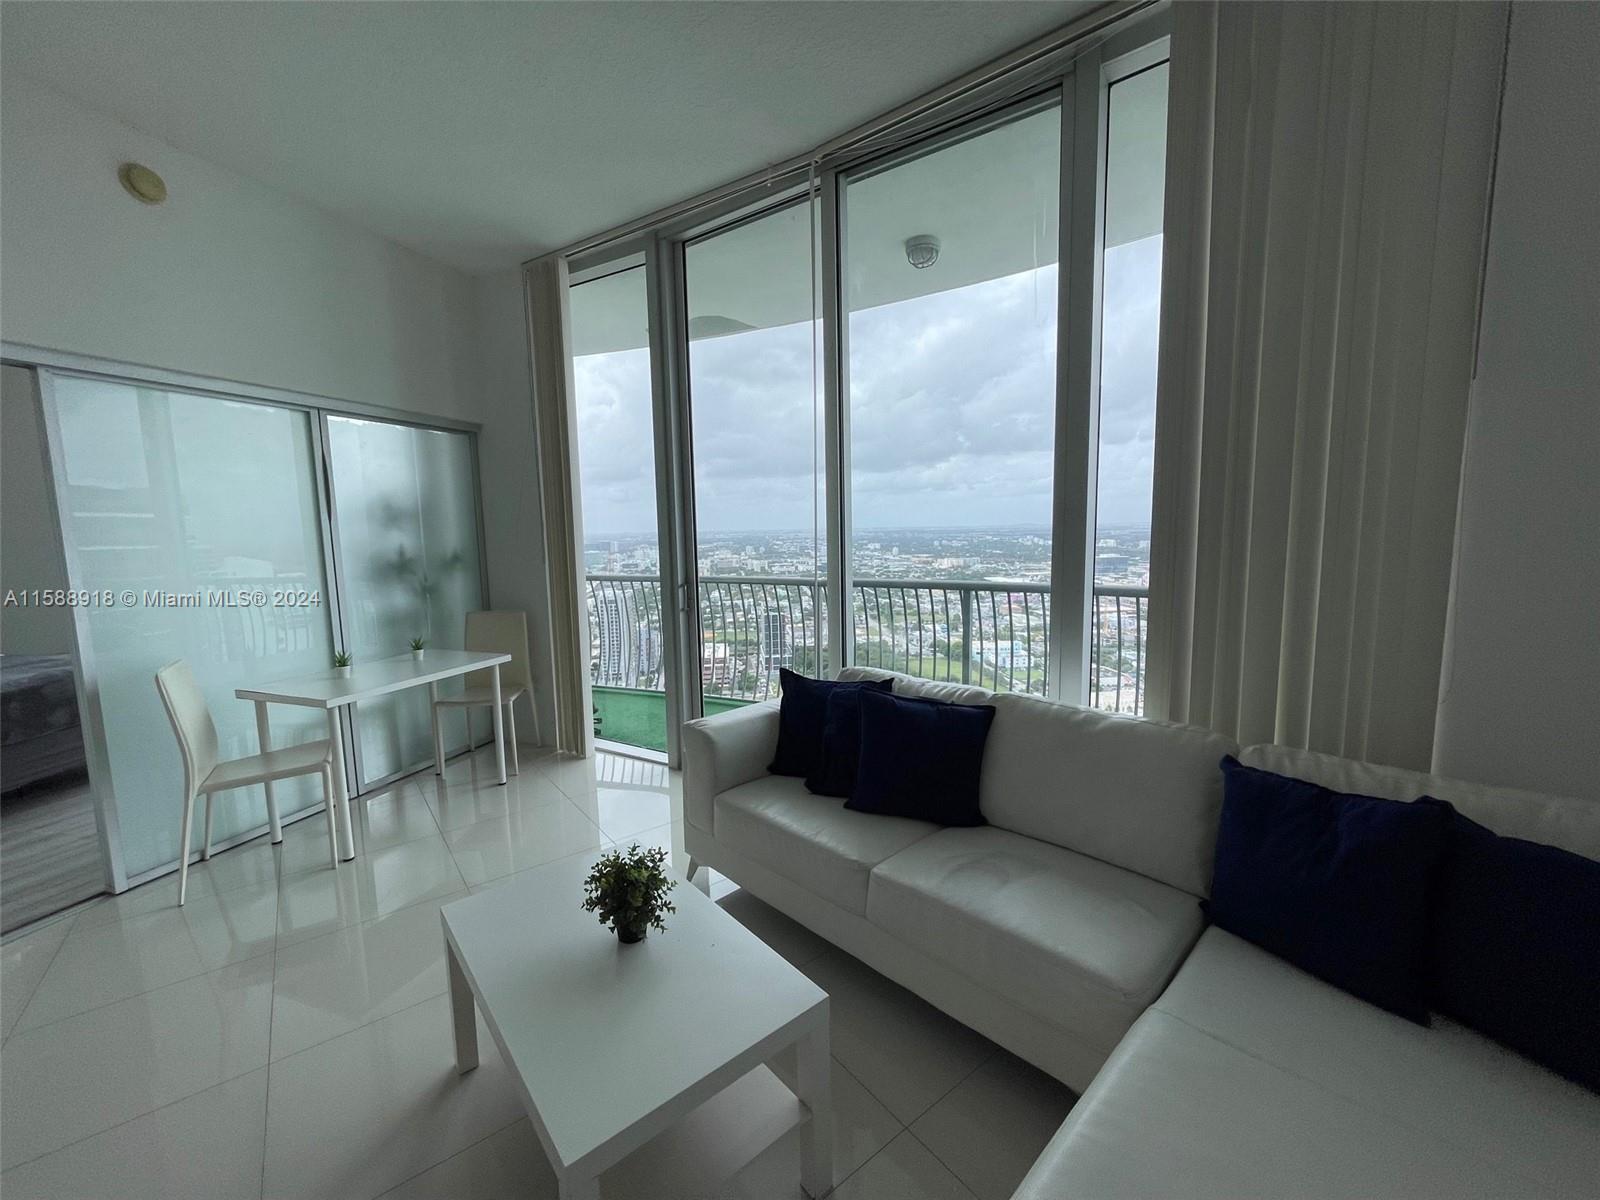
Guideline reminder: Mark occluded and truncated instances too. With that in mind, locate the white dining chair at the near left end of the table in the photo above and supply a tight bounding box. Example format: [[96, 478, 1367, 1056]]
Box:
[[155, 659, 339, 904]]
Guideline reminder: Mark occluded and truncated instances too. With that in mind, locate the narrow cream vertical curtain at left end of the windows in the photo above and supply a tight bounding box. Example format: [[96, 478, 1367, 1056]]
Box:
[[526, 254, 594, 754]]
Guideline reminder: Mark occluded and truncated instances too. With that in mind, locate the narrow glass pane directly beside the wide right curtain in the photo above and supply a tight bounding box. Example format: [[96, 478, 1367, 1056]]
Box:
[[1090, 62, 1166, 712]]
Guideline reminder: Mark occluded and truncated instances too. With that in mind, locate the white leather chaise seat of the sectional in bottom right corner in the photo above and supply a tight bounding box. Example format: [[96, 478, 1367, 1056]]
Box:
[[1016, 928, 1600, 1200]]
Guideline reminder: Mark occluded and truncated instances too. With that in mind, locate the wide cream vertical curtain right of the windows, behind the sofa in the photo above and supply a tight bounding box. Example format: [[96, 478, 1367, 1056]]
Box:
[[1147, 3, 1507, 770]]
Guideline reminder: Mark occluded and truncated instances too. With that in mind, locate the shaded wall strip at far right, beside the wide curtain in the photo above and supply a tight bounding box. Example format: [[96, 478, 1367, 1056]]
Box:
[[1434, 3, 1600, 800]]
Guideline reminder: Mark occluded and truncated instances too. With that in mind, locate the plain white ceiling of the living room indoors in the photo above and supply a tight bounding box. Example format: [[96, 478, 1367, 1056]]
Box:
[[0, 0, 1096, 272]]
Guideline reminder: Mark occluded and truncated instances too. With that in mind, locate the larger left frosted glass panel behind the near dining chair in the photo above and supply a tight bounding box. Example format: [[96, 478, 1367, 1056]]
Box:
[[51, 376, 333, 877]]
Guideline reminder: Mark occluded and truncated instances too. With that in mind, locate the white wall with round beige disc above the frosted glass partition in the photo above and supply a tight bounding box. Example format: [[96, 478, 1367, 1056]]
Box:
[[0, 72, 552, 741]]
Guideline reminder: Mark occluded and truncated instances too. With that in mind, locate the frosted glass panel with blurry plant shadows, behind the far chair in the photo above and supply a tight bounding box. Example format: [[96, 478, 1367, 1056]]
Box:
[[328, 416, 476, 787]]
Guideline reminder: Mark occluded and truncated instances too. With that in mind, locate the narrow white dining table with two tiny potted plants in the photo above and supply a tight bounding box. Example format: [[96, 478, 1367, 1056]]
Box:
[[234, 650, 510, 862]]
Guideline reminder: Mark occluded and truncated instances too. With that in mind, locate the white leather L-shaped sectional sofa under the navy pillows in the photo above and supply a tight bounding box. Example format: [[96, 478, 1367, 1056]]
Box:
[[683, 669, 1600, 1200]]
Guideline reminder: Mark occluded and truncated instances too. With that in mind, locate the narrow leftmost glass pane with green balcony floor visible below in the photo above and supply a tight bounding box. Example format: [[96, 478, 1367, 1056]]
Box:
[[568, 267, 667, 750]]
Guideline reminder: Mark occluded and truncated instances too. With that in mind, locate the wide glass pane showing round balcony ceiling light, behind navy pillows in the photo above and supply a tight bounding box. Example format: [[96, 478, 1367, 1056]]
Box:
[[845, 107, 1061, 693]]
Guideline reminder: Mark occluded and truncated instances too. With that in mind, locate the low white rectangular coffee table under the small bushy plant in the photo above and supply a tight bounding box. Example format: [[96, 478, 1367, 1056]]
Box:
[[442, 856, 834, 1200]]
